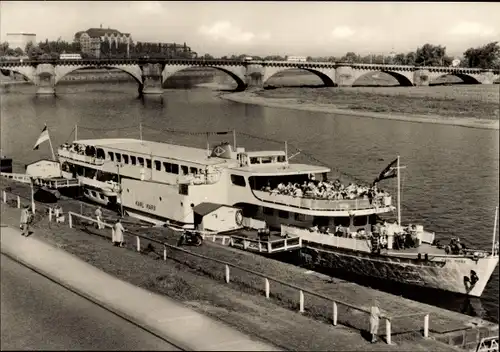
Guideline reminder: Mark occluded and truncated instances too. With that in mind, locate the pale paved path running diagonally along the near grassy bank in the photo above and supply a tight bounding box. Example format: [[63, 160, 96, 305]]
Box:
[[1, 225, 279, 351]]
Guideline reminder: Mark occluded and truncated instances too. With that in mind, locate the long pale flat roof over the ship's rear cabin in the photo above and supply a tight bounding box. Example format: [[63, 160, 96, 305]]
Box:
[[75, 138, 236, 165]]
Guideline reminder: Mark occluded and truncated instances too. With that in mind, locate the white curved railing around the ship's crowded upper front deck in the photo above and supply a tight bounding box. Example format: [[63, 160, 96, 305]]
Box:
[[253, 190, 392, 211]]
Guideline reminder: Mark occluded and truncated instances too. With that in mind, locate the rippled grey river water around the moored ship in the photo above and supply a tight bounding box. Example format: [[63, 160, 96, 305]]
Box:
[[0, 82, 499, 321]]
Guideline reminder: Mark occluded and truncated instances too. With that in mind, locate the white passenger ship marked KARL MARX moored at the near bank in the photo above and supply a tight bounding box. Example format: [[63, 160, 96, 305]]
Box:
[[58, 139, 498, 296]]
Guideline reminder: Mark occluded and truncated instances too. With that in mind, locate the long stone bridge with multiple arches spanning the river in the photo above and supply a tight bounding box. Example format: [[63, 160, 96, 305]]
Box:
[[0, 59, 500, 94]]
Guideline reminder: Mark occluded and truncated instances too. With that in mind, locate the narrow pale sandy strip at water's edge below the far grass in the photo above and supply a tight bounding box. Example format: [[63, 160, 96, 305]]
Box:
[[220, 92, 499, 130]]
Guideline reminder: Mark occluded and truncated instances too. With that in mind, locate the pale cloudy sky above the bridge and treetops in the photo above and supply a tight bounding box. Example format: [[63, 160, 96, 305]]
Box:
[[0, 1, 500, 56]]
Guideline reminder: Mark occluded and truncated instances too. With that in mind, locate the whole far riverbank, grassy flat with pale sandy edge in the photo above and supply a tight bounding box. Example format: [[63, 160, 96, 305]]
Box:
[[220, 86, 499, 130]]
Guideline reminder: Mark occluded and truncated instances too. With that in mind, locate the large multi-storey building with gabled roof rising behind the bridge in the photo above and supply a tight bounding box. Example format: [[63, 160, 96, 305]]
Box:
[[74, 25, 133, 57]]
